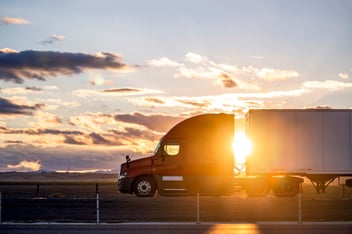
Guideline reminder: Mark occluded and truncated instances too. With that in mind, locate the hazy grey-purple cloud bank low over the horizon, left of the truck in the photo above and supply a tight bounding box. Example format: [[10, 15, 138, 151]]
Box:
[[0, 144, 125, 173]]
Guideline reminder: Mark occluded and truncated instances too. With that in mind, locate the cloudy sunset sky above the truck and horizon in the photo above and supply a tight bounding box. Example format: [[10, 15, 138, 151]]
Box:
[[0, 0, 352, 172]]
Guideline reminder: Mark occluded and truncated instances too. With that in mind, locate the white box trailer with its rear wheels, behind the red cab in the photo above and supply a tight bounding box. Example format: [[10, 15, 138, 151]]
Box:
[[246, 109, 352, 196]]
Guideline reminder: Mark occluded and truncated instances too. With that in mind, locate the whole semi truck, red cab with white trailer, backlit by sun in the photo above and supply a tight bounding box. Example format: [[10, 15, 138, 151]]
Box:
[[118, 109, 352, 197]]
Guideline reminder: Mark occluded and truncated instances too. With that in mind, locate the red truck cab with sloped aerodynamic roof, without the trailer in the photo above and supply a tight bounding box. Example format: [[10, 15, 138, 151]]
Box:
[[118, 114, 234, 196]]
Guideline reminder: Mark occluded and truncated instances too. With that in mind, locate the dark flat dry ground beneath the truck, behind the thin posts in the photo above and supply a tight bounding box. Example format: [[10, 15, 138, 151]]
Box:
[[0, 173, 352, 222]]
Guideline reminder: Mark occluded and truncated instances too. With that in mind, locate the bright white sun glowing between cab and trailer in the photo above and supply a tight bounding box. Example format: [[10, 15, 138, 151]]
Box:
[[232, 132, 252, 164]]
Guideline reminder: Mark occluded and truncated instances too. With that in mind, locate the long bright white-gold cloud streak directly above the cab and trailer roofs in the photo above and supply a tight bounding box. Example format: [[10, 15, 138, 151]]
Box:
[[130, 88, 310, 115]]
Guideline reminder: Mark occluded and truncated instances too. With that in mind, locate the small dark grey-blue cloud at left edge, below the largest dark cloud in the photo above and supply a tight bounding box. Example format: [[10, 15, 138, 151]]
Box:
[[0, 97, 44, 115]]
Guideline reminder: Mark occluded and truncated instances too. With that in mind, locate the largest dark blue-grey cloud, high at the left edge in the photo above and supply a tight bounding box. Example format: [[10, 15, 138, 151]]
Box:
[[0, 49, 127, 83]]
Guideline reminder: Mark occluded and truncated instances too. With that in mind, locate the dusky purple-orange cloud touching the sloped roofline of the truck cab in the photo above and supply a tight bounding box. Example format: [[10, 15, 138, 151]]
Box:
[[115, 112, 184, 132]]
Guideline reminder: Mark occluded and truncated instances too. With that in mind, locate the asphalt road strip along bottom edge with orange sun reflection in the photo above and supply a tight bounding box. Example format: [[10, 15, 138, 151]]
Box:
[[0, 223, 352, 234]]
